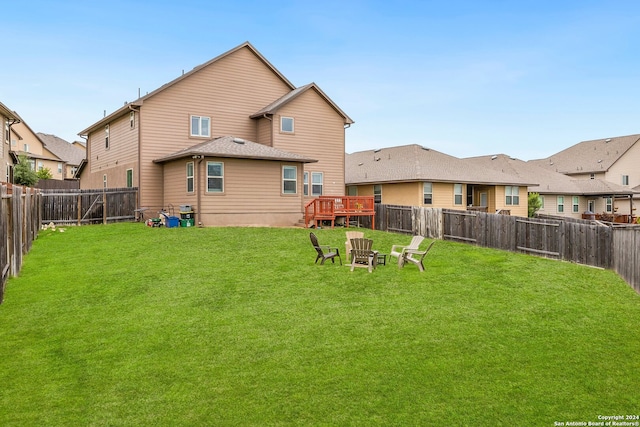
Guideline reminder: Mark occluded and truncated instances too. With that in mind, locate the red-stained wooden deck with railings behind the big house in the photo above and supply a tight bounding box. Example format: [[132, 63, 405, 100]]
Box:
[[304, 196, 376, 228]]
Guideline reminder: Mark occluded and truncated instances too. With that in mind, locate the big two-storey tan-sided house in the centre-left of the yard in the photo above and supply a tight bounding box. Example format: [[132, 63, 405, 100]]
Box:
[[80, 43, 353, 225]]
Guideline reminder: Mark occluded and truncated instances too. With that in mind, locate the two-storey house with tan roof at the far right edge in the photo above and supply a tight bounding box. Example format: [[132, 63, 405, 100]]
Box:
[[528, 135, 640, 215]]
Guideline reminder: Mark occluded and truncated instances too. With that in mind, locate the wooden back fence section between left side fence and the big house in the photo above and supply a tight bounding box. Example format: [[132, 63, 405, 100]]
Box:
[[41, 188, 138, 225]]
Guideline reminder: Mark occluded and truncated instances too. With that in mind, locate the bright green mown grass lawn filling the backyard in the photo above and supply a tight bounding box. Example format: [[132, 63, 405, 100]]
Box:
[[0, 224, 640, 426]]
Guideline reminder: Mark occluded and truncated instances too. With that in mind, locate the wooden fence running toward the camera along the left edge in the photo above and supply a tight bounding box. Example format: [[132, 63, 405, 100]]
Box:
[[0, 184, 41, 303]]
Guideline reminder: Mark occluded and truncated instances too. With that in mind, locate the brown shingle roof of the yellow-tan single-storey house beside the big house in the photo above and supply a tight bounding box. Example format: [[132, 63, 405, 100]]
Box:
[[345, 144, 537, 186]]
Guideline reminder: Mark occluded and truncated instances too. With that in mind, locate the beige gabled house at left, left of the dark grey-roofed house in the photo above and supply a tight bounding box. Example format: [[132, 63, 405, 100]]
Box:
[[9, 115, 64, 179]]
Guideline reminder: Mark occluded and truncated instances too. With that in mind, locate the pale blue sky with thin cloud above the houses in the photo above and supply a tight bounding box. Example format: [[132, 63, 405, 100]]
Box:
[[0, 0, 640, 160]]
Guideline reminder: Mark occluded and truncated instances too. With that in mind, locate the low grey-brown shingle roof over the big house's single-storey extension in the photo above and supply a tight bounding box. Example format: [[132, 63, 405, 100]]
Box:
[[153, 136, 317, 163]]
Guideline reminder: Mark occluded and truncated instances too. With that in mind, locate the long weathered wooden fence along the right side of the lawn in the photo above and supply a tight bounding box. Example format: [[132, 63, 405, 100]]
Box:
[[370, 204, 640, 293]]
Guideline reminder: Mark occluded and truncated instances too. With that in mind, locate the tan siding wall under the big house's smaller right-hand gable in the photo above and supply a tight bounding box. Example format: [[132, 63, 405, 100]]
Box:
[[273, 90, 345, 196]]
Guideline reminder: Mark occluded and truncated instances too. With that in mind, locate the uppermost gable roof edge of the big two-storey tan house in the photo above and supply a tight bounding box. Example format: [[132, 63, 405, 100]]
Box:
[[78, 42, 296, 135]]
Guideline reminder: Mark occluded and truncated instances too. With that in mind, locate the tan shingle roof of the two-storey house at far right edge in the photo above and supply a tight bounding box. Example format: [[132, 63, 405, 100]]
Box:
[[529, 135, 640, 175]]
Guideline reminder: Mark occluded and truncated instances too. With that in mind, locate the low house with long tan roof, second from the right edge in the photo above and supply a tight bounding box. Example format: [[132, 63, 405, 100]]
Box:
[[464, 154, 634, 218]]
